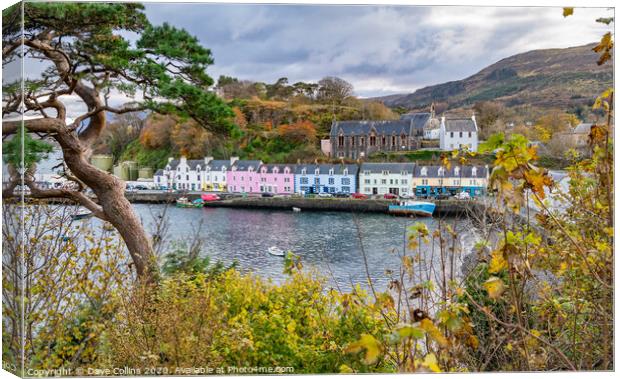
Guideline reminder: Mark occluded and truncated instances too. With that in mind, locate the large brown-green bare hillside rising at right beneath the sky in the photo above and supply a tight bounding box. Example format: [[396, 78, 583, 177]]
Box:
[[374, 44, 613, 109]]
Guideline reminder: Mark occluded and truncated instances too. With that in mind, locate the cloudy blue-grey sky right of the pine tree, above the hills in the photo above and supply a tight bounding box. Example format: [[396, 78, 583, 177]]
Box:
[[146, 3, 612, 97]]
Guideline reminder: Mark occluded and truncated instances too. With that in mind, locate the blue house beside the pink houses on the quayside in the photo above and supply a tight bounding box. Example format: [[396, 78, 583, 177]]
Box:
[[295, 164, 358, 194]]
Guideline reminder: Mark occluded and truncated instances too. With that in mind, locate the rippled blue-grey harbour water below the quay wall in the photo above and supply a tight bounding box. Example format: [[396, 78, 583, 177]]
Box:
[[134, 204, 476, 289]]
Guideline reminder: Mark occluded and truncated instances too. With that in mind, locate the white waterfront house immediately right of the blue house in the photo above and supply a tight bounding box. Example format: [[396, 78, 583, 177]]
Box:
[[359, 163, 415, 195]]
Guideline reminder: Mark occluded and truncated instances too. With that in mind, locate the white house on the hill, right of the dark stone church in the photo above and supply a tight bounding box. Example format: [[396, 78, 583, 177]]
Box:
[[439, 116, 478, 151]]
